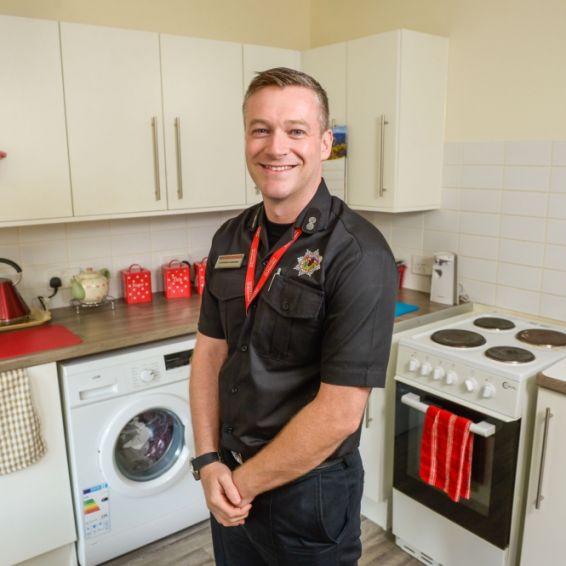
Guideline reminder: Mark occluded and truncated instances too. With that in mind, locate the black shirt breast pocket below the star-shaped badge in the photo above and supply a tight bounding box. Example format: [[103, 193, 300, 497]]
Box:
[[254, 276, 324, 364]]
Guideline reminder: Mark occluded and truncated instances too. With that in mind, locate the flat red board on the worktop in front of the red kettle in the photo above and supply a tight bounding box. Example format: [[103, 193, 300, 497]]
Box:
[[0, 324, 82, 359]]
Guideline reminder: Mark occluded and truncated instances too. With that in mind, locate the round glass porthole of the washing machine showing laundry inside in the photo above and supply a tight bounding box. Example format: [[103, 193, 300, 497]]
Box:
[[114, 409, 185, 482]]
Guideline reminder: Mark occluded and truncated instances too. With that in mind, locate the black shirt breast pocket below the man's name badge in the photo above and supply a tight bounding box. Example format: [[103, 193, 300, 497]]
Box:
[[210, 269, 246, 345]]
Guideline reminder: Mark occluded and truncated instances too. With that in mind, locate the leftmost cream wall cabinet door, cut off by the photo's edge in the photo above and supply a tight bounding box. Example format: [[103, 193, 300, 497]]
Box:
[[0, 16, 72, 223]]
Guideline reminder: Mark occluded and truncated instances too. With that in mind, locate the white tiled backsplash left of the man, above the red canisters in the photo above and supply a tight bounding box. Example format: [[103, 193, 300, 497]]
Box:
[[0, 211, 229, 308]]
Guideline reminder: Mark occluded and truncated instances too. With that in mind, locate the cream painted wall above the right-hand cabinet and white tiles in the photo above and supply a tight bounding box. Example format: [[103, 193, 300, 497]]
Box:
[[311, 0, 566, 141]]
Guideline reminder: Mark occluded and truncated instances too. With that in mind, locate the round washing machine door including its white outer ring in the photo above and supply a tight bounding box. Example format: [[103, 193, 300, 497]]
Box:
[[98, 393, 192, 497]]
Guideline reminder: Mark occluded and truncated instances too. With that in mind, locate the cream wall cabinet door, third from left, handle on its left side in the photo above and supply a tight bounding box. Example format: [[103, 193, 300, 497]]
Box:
[[161, 35, 245, 209]]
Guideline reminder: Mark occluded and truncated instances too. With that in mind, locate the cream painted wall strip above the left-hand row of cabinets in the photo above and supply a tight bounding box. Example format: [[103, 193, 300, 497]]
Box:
[[0, 0, 310, 49]]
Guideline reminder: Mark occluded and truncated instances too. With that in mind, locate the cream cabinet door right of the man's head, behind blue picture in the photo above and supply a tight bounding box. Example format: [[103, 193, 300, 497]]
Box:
[[302, 43, 346, 199]]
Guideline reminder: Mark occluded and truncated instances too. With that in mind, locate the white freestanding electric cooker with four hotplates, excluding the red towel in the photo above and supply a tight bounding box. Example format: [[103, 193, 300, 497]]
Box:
[[393, 313, 566, 566]]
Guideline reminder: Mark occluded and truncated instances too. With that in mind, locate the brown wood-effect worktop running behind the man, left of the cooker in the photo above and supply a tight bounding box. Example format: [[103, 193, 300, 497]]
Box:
[[0, 289, 472, 371]]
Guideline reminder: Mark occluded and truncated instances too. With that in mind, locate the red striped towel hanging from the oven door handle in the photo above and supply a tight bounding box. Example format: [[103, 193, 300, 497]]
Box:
[[419, 405, 474, 502]]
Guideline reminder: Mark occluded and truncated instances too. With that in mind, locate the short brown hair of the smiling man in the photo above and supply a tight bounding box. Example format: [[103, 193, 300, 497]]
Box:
[[242, 67, 330, 132]]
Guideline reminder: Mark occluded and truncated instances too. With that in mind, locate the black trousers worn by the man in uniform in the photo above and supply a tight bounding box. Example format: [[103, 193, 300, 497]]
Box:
[[211, 450, 364, 566]]
